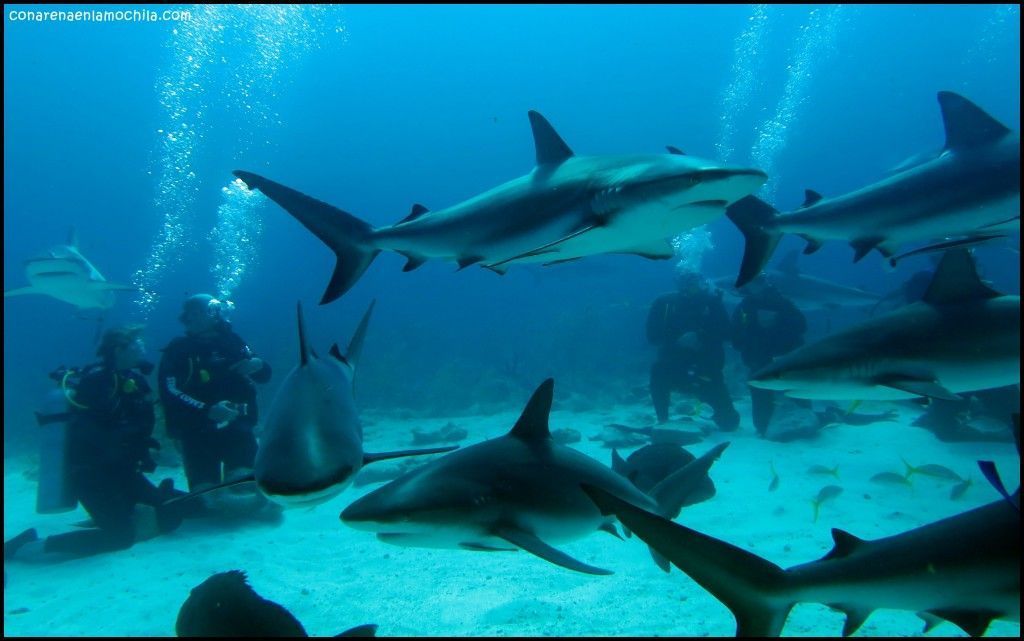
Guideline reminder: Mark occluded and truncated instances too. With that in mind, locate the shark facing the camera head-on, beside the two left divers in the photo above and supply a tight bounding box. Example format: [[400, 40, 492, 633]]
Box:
[[168, 300, 458, 507]]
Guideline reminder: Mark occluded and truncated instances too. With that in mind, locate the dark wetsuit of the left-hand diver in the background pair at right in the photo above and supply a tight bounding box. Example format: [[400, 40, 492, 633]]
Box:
[[647, 291, 739, 430]]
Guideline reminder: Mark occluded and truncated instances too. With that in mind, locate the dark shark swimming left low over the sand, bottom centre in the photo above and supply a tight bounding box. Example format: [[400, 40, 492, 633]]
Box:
[[341, 379, 725, 574]]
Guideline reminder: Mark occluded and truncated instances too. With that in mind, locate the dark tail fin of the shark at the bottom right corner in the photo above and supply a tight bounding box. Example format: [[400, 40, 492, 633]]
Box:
[[582, 483, 796, 637]]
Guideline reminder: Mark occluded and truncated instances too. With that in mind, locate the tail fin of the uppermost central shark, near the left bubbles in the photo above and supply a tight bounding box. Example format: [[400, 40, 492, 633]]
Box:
[[233, 171, 380, 305]]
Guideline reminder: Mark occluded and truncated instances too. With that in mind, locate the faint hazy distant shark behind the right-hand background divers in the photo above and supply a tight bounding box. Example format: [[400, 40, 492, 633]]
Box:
[[713, 251, 882, 311]]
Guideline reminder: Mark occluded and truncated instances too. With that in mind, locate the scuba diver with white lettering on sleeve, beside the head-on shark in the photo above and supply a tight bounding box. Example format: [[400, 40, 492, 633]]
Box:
[[158, 294, 270, 490]]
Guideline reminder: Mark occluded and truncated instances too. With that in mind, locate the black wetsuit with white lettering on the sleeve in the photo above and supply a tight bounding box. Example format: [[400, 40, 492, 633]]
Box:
[[159, 323, 270, 489]]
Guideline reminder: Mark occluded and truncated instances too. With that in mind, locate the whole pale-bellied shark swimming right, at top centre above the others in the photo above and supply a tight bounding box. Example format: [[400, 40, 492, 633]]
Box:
[[233, 111, 767, 304]]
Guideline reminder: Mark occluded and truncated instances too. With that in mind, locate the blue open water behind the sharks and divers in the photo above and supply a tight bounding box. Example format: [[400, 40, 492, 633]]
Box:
[[4, 5, 1020, 634]]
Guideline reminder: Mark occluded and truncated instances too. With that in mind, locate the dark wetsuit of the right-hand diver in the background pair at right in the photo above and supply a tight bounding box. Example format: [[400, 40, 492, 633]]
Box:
[[732, 291, 807, 436]]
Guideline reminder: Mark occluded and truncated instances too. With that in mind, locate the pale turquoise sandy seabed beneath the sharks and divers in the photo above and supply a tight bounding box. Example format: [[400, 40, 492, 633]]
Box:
[[4, 399, 1020, 637]]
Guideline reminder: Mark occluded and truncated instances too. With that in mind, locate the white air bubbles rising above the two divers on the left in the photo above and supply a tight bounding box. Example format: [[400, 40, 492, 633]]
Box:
[[133, 5, 345, 317]]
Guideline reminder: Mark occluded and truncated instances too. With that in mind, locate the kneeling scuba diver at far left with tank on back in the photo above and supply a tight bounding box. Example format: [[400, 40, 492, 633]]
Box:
[[4, 326, 186, 560]]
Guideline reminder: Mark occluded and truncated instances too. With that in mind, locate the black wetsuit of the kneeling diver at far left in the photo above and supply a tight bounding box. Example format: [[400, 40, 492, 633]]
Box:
[[43, 366, 183, 556]]
